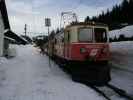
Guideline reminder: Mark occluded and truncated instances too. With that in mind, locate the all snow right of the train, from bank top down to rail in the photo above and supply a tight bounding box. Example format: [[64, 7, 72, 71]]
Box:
[[110, 41, 133, 96]]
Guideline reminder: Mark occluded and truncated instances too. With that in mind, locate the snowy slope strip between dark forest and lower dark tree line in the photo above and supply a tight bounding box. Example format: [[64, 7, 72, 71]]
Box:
[[109, 25, 133, 38]]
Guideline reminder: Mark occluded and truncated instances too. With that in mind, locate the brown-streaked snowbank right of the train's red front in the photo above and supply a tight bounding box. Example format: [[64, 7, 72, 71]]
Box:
[[110, 41, 133, 72]]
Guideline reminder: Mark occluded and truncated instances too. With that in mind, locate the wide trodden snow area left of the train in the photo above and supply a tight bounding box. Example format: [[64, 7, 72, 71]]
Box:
[[0, 45, 104, 100]]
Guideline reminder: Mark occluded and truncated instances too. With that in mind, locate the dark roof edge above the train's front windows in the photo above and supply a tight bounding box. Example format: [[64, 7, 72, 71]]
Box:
[[67, 22, 108, 27]]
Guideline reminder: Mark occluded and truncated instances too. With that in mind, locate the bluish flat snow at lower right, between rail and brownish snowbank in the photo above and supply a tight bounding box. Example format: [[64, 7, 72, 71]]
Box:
[[110, 68, 133, 97]]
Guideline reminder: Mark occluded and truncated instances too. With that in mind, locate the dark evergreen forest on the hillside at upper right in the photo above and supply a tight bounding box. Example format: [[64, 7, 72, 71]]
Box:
[[85, 0, 133, 30]]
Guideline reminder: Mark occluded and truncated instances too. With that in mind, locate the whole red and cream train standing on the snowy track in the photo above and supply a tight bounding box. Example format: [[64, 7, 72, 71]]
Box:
[[44, 22, 111, 84]]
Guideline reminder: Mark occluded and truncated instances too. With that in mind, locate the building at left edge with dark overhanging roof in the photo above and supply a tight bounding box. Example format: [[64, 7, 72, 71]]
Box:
[[0, 0, 27, 56]]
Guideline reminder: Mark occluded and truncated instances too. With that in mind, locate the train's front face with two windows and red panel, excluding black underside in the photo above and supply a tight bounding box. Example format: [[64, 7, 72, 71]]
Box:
[[69, 23, 110, 62]]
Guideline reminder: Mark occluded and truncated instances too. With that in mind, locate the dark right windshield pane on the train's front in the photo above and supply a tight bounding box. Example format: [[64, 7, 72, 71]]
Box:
[[94, 28, 107, 42]]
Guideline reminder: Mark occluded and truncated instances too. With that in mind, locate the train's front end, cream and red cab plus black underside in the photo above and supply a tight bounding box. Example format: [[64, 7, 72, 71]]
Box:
[[64, 23, 111, 84]]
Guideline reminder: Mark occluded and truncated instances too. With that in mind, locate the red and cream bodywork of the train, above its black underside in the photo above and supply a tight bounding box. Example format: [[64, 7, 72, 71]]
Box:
[[54, 23, 110, 62]]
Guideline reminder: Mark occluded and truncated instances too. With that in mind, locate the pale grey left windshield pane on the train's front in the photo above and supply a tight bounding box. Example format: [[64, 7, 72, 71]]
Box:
[[79, 28, 93, 42]]
